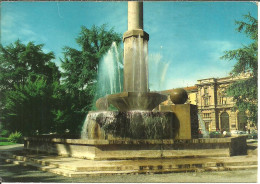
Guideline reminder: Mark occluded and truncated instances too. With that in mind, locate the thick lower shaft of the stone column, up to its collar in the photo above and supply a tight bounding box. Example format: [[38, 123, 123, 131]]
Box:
[[123, 29, 149, 92]]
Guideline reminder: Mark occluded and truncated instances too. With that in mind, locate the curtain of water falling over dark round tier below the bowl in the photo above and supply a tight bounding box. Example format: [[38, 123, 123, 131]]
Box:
[[81, 110, 178, 139]]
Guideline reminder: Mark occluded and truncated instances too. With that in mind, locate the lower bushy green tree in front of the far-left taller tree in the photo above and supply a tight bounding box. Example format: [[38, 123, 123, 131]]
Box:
[[3, 77, 53, 135]]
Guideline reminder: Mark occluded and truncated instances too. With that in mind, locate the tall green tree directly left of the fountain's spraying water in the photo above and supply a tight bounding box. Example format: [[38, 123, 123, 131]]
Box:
[[60, 25, 121, 132]]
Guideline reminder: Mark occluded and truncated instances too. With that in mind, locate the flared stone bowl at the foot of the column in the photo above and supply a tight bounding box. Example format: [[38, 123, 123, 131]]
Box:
[[107, 92, 167, 111]]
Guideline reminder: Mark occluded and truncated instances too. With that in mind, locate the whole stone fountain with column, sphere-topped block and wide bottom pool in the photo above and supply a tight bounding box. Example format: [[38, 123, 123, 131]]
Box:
[[24, 1, 246, 174]]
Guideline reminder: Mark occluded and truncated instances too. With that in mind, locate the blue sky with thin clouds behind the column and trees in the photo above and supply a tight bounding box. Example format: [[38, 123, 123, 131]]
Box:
[[1, 2, 257, 90]]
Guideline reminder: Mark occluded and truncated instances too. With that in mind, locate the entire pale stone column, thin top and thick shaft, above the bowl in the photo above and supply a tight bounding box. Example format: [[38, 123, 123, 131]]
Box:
[[123, 1, 149, 92]]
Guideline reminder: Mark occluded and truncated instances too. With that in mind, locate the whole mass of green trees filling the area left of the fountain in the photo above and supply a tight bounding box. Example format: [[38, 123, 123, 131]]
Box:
[[0, 25, 121, 136]]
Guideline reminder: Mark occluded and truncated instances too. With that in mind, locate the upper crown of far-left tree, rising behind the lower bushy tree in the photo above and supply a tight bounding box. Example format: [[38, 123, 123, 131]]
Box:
[[0, 40, 60, 91]]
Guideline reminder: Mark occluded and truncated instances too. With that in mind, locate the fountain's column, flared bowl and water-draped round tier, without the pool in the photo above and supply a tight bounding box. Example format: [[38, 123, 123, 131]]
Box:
[[84, 2, 179, 140]]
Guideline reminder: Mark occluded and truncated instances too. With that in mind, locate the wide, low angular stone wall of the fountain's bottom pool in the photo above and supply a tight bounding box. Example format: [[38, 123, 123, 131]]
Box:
[[24, 136, 247, 160]]
